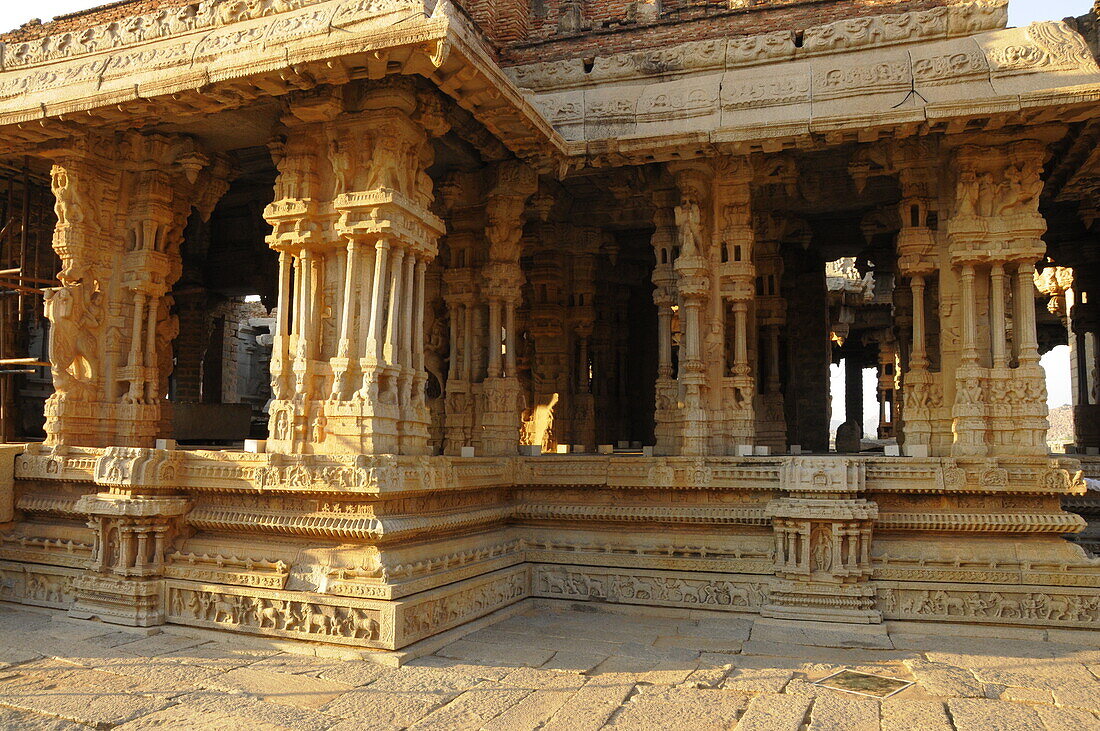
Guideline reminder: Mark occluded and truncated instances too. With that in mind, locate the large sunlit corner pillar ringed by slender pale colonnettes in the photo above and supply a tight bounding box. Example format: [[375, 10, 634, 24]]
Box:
[[264, 85, 446, 454]]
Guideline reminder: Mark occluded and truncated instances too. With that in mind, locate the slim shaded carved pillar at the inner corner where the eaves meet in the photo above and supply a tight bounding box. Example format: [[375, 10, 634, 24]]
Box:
[[479, 162, 538, 455]]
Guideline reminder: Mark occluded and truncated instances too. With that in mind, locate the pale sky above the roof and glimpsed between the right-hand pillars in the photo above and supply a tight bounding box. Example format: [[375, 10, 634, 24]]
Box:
[[0, 0, 1092, 424]]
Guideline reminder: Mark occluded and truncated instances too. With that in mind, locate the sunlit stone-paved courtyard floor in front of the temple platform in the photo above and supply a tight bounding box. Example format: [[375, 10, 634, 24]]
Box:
[[0, 605, 1100, 731]]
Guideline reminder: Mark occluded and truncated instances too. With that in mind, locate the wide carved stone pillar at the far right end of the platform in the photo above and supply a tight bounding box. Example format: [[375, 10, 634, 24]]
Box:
[[947, 141, 1046, 455]]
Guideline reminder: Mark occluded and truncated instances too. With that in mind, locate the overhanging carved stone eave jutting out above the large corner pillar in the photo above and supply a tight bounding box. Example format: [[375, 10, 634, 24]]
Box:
[[0, 2, 565, 170]]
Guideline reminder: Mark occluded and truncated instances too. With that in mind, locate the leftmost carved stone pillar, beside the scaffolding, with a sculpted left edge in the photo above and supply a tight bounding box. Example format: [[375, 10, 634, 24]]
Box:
[[45, 133, 229, 447]]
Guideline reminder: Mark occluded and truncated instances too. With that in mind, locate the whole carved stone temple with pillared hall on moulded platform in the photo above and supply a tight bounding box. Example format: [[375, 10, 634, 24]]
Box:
[[0, 0, 1100, 650]]
